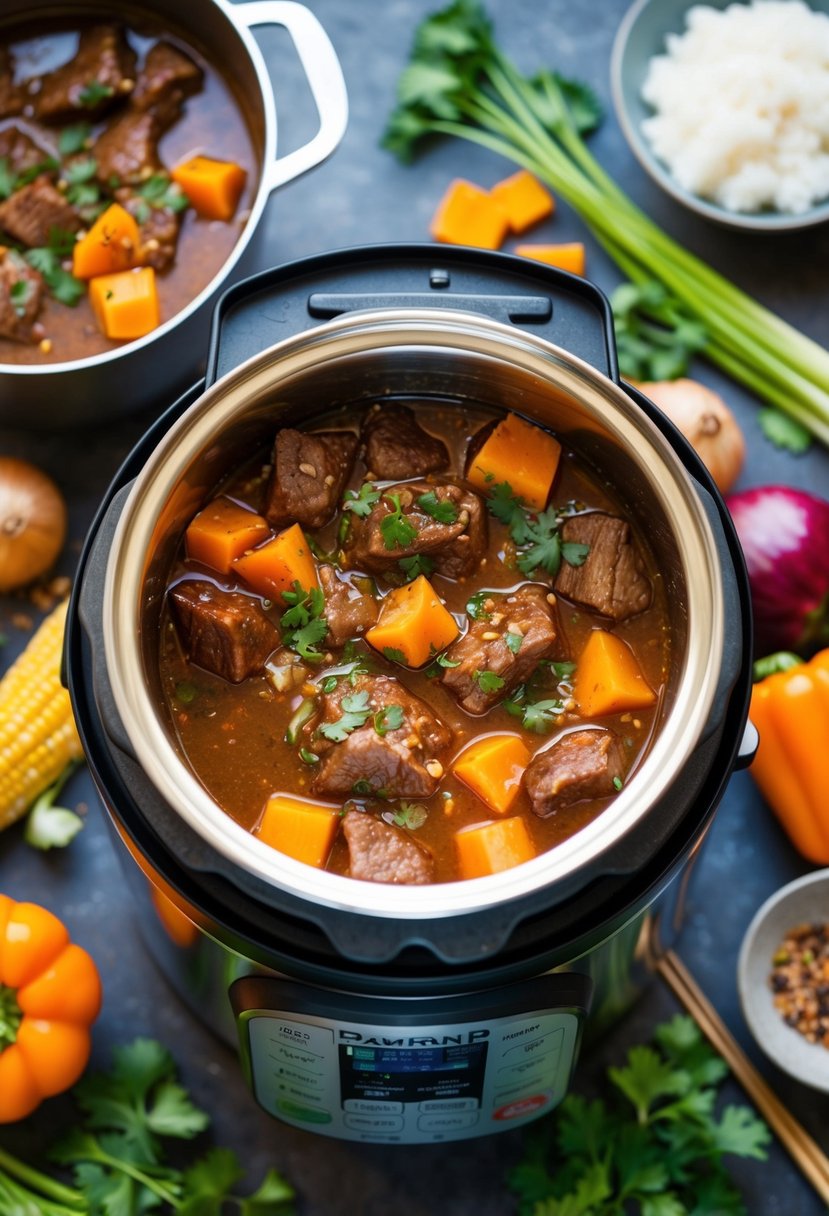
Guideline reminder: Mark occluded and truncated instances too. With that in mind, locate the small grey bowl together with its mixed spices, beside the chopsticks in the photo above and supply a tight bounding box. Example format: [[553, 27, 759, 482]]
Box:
[[737, 869, 829, 1092]]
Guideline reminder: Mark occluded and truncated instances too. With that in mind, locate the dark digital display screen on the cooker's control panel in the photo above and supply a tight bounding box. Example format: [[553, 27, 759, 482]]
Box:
[[339, 1043, 487, 1102]]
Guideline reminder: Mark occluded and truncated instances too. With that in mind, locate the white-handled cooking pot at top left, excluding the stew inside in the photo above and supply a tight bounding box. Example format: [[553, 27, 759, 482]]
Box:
[[0, 0, 348, 429]]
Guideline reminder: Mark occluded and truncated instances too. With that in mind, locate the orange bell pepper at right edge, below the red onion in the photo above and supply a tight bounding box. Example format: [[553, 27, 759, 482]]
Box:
[[749, 648, 829, 866]]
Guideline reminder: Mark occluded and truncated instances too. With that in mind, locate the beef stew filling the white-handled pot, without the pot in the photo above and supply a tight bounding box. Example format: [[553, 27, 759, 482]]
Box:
[[0, 18, 258, 364]]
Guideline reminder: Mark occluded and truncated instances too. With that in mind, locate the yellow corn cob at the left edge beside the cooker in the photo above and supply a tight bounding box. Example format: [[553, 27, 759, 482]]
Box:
[[0, 601, 81, 829]]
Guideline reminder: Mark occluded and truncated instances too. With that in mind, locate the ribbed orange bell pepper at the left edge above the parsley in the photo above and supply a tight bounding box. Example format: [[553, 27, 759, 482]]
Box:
[[0, 895, 101, 1124]]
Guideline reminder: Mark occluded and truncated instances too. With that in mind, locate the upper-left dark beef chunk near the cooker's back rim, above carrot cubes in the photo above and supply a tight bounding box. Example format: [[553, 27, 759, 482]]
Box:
[[265, 427, 357, 528]]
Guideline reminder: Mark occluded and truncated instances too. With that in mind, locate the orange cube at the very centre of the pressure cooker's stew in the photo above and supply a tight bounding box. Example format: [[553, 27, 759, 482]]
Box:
[[366, 574, 461, 668]]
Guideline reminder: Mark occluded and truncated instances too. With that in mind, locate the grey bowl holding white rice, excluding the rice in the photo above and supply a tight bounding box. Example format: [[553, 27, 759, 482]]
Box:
[[610, 0, 829, 232]]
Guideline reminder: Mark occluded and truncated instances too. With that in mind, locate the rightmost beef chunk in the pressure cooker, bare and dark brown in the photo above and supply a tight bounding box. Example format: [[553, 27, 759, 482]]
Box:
[[554, 511, 653, 620]]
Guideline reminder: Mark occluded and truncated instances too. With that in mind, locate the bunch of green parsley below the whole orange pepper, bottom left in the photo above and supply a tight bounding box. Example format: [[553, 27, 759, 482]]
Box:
[[0, 1038, 295, 1216]]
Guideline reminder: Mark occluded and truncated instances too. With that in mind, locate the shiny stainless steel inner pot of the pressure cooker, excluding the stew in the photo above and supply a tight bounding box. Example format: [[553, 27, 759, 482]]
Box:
[[103, 309, 734, 921]]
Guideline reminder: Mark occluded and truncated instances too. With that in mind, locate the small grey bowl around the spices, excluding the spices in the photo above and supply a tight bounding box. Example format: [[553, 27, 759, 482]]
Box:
[[737, 869, 829, 1092]]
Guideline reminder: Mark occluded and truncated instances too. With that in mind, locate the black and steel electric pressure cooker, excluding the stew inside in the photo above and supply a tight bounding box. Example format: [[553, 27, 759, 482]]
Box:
[[66, 244, 751, 1143]]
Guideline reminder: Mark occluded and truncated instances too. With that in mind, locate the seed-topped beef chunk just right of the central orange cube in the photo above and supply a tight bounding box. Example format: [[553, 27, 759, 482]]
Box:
[[440, 584, 557, 714]]
